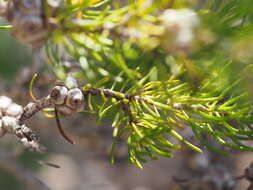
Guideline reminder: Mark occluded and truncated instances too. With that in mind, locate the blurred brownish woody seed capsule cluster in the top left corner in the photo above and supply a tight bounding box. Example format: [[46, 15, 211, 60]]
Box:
[[6, 0, 47, 48]]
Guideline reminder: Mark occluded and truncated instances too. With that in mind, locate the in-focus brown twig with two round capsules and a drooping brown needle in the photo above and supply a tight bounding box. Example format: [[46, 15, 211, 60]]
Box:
[[12, 86, 140, 151]]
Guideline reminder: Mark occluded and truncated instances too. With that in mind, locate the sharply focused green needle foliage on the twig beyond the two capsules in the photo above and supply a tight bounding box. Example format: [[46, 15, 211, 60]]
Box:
[[77, 63, 253, 168]]
